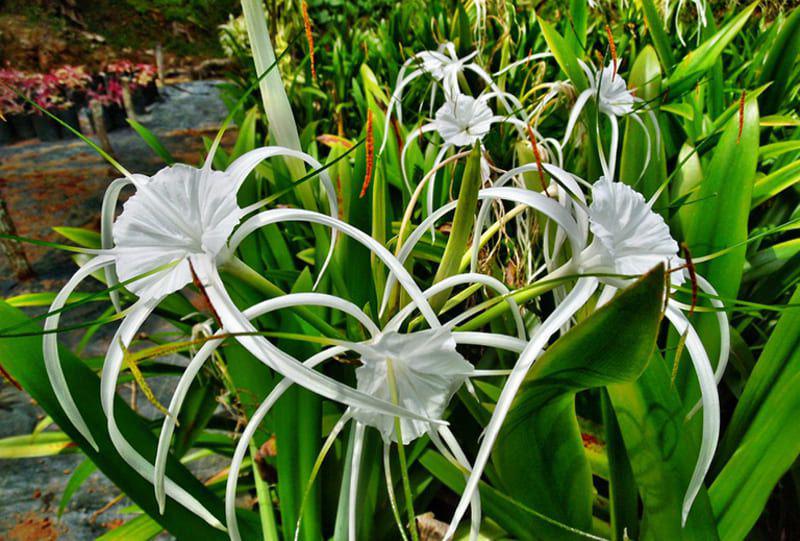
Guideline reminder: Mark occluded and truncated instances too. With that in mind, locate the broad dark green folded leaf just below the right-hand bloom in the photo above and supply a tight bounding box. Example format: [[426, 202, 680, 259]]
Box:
[[492, 267, 664, 530]]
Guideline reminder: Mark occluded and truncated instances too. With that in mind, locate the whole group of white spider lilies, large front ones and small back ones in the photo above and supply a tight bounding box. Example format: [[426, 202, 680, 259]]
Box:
[[44, 27, 729, 539]]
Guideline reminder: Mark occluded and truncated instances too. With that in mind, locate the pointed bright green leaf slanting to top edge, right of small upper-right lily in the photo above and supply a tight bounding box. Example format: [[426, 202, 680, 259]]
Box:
[[667, 1, 758, 95]]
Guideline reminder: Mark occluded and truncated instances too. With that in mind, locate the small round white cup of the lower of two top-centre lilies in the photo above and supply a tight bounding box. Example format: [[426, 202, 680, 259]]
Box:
[[433, 94, 498, 147]]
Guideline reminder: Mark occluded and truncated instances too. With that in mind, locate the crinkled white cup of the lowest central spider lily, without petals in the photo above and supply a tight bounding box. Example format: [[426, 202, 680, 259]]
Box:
[[353, 329, 473, 445]]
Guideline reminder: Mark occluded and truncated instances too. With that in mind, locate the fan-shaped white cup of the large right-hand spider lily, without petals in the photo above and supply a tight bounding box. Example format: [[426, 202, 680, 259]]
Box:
[[581, 177, 684, 286]]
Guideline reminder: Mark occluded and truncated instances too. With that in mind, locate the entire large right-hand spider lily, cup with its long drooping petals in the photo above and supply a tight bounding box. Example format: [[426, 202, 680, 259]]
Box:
[[396, 174, 730, 539]]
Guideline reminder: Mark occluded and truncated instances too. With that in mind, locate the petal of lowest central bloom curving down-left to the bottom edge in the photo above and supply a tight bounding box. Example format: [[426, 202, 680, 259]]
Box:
[[225, 346, 347, 541]]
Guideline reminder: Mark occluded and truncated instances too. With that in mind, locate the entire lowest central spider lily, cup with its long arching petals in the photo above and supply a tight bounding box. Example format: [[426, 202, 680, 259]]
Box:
[[154, 260, 525, 539]]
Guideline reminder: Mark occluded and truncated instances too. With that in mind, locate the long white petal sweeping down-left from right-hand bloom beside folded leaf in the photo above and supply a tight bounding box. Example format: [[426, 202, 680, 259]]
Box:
[[444, 278, 598, 539]]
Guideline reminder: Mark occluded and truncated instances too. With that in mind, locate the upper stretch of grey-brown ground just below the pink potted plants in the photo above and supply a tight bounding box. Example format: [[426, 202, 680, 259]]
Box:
[[0, 81, 235, 296]]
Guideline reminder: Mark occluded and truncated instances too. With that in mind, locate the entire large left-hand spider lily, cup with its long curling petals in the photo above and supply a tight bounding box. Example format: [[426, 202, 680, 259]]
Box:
[[43, 147, 422, 528]]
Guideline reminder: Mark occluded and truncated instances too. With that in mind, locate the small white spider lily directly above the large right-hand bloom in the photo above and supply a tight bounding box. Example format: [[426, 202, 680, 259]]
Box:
[[561, 61, 661, 178]]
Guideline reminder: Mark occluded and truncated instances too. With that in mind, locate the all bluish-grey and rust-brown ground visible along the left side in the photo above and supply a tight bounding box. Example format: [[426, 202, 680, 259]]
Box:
[[0, 82, 235, 541]]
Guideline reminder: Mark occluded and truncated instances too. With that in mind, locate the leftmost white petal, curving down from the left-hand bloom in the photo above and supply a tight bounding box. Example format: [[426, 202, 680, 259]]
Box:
[[42, 256, 114, 451]]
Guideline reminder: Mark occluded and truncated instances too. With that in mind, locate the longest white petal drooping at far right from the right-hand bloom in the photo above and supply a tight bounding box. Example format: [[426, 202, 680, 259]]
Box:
[[666, 304, 720, 525]]
